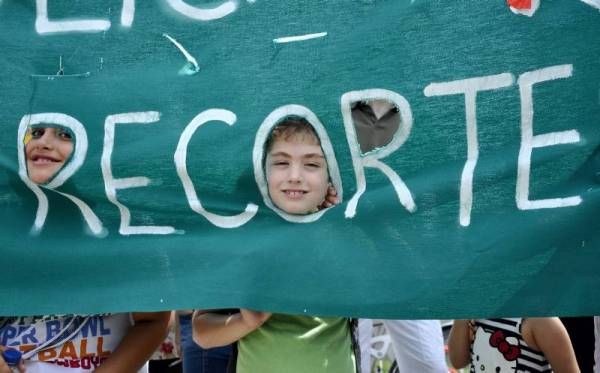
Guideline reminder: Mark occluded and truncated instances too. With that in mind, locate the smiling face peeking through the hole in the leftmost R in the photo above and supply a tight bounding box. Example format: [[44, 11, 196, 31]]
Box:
[[25, 127, 73, 184]]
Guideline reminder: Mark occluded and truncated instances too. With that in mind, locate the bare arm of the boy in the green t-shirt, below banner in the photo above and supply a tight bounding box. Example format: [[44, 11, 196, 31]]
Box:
[[192, 308, 271, 348]]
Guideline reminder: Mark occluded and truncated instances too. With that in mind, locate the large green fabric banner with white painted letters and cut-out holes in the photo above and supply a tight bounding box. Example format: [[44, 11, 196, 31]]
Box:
[[0, 0, 600, 318]]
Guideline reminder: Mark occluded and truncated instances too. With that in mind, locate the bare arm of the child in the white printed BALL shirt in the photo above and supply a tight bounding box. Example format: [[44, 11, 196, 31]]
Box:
[[95, 311, 171, 373]]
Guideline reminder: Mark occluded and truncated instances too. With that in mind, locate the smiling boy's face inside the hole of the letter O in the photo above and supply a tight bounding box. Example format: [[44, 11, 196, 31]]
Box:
[[265, 133, 329, 215]]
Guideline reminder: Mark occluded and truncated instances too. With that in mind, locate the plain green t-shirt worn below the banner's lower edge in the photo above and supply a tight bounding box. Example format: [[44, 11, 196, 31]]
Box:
[[237, 314, 356, 373]]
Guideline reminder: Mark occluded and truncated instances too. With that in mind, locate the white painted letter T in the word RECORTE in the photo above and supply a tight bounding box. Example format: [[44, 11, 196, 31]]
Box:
[[424, 73, 515, 227]]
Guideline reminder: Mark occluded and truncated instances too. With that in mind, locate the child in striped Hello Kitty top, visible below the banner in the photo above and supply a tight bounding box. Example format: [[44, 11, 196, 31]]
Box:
[[448, 317, 579, 373]]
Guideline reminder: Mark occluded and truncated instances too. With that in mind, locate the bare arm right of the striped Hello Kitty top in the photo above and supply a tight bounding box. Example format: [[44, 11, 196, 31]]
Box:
[[522, 317, 579, 373]]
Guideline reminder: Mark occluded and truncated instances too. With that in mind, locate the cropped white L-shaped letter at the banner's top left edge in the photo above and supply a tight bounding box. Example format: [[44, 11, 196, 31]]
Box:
[[35, 0, 110, 34]]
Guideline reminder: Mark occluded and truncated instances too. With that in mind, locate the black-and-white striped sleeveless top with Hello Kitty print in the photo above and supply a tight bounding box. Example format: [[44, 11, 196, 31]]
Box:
[[471, 319, 552, 373]]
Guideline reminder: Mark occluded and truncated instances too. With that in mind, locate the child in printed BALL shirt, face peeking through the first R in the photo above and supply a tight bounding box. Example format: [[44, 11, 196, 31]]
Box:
[[0, 124, 169, 373]]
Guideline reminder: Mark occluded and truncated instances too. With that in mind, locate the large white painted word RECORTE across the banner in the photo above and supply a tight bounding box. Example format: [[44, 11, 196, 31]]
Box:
[[18, 65, 582, 236]]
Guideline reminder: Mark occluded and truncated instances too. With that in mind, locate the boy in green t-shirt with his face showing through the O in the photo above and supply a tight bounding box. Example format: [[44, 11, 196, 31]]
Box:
[[193, 117, 356, 373]]
